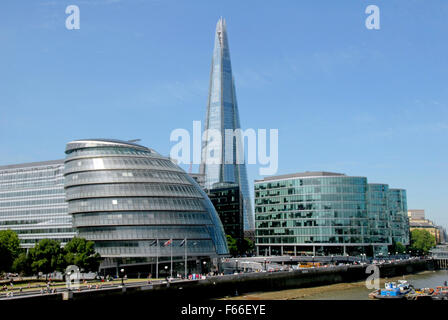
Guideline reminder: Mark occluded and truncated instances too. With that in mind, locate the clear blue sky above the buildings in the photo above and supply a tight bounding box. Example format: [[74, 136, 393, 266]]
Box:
[[0, 0, 448, 226]]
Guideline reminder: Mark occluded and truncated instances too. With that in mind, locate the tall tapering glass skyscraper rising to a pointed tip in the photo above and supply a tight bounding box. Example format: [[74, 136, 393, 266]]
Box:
[[200, 18, 255, 230]]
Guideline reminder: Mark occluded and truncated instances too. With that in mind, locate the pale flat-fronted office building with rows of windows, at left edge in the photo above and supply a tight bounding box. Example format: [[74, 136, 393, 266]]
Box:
[[0, 160, 75, 248]]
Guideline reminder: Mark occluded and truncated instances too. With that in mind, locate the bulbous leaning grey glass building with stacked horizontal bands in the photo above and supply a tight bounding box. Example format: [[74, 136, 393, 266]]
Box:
[[64, 139, 228, 274]]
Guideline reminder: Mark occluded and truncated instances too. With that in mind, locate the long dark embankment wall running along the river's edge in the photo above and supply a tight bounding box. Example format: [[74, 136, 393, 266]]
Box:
[[2, 259, 433, 303]]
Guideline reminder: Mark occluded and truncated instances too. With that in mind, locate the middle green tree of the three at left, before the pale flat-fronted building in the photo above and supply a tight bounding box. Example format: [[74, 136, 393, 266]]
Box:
[[29, 239, 66, 274]]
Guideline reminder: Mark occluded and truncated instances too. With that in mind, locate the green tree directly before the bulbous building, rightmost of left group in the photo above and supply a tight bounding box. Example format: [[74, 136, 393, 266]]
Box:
[[64, 237, 101, 271]]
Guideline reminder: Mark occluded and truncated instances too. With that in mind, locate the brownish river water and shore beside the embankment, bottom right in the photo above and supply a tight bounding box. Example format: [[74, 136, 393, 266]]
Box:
[[224, 270, 448, 300]]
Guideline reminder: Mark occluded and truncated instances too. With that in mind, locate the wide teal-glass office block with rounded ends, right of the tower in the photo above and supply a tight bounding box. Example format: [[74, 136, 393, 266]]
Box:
[[255, 172, 409, 255]]
